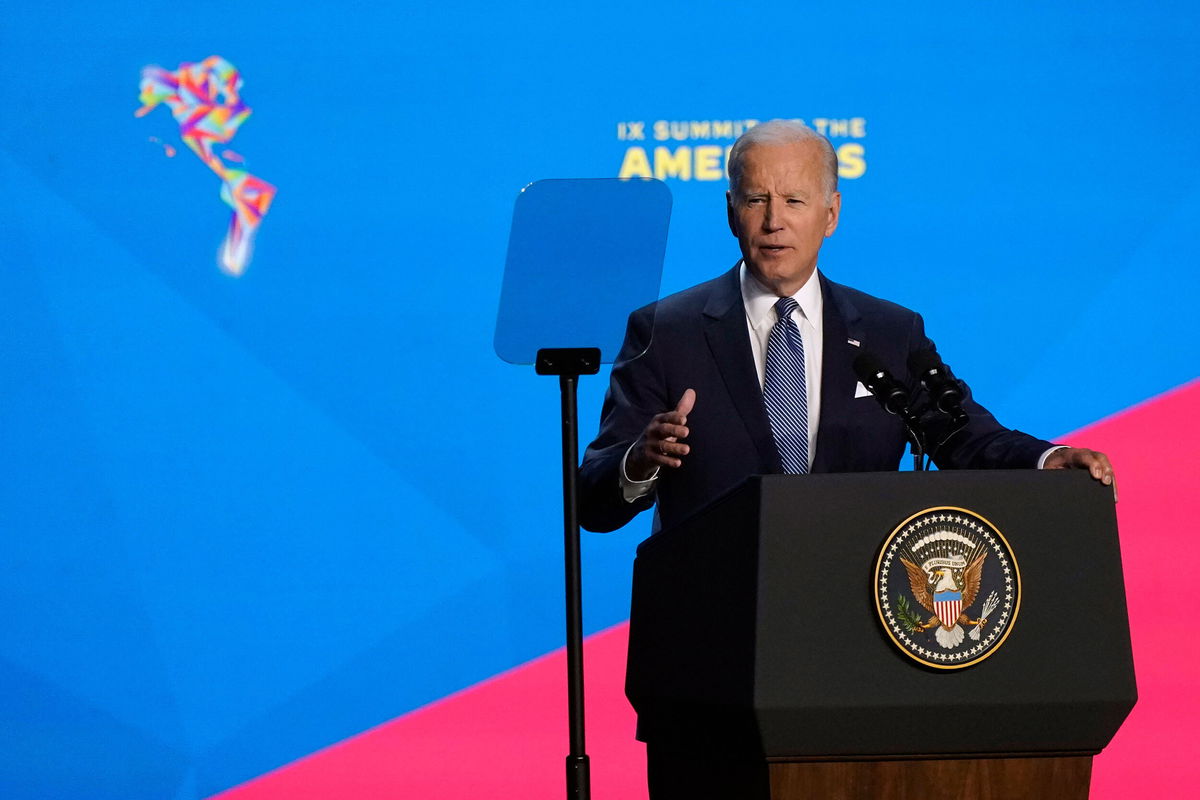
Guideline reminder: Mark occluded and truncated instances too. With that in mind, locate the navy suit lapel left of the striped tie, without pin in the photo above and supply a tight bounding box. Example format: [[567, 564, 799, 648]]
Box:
[[703, 267, 781, 473]]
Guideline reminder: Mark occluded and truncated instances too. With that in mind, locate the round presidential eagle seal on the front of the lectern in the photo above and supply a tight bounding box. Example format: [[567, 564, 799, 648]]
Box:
[[875, 506, 1021, 669]]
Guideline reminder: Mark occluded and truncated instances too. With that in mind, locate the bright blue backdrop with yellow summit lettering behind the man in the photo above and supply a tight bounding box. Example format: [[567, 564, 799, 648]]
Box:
[[0, 0, 1200, 799]]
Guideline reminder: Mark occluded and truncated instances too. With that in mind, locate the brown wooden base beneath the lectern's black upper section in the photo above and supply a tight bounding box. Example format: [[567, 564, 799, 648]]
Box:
[[647, 746, 1092, 800]]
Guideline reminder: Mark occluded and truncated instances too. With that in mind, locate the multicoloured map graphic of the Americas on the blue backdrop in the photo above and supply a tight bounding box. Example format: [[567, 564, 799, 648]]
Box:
[[134, 55, 276, 276]]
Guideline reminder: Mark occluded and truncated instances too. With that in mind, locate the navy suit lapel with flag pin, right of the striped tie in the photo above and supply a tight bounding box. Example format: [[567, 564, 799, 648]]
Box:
[[812, 275, 863, 473]]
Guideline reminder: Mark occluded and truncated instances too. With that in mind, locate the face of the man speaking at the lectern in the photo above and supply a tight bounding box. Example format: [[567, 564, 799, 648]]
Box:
[[726, 142, 841, 297]]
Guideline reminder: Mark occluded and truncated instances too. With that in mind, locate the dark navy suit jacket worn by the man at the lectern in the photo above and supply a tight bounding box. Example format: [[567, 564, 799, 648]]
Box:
[[580, 267, 1052, 531]]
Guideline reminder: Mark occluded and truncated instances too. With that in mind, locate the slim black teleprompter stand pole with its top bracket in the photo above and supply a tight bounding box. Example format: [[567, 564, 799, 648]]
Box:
[[535, 348, 600, 800]]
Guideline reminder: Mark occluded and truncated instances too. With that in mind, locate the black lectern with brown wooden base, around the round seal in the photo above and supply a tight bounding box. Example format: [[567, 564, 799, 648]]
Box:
[[626, 470, 1136, 800]]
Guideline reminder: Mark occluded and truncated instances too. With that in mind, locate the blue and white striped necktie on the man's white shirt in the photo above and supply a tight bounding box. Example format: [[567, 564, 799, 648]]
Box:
[[762, 297, 809, 475]]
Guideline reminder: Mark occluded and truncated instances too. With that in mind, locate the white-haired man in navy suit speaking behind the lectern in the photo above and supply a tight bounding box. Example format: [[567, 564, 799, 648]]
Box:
[[580, 120, 1114, 531]]
